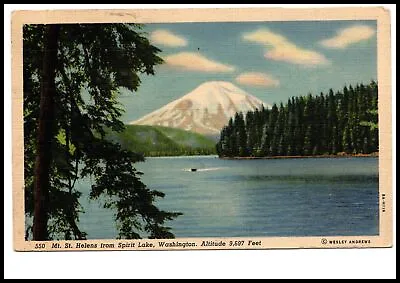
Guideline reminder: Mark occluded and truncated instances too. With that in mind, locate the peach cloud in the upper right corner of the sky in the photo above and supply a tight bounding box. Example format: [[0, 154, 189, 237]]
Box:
[[320, 25, 375, 49]]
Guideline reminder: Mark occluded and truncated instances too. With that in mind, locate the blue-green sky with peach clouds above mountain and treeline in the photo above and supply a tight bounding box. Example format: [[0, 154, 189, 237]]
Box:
[[120, 21, 377, 122]]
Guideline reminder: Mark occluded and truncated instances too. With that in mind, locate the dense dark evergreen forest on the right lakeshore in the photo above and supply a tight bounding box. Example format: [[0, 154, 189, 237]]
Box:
[[216, 81, 378, 157]]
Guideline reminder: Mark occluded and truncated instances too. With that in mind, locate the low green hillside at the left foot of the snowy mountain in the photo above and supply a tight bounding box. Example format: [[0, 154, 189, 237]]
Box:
[[108, 125, 215, 156]]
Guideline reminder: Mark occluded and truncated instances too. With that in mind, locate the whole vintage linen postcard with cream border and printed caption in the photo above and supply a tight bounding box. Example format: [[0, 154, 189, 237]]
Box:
[[12, 7, 392, 251]]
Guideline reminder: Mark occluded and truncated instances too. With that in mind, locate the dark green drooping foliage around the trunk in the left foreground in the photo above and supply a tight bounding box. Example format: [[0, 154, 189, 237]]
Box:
[[23, 24, 179, 239]]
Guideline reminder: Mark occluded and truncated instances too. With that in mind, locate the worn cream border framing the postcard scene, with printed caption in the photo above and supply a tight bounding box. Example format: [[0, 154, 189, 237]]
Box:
[[11, 7, 393, 251]]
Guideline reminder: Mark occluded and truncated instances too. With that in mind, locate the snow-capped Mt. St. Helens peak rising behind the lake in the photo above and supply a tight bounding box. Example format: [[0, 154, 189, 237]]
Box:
[[130, 81, 270, 135]]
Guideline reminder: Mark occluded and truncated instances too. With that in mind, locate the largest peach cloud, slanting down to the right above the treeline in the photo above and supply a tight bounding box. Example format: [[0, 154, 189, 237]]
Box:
[[243, 28, 330, 66]]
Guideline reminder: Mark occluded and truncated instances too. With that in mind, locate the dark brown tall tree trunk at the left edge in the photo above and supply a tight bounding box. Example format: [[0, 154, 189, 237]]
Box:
[[33, 25, 60, 241]]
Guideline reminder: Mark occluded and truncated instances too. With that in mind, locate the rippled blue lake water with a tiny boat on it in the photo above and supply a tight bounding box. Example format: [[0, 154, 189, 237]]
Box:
[[78, 156, 379, 239]]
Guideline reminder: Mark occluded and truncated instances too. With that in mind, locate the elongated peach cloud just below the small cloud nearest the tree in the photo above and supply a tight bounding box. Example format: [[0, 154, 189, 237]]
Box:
[[163, 52, 235, 73]]
